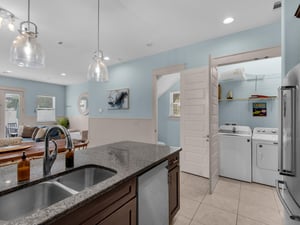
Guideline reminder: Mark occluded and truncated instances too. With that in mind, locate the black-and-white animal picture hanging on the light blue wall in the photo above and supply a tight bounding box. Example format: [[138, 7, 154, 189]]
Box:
[[107, 88, 129, 109]]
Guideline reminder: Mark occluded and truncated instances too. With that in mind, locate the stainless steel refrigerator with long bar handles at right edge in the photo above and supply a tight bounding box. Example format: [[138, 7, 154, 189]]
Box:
[[276, 64, 300, 225]]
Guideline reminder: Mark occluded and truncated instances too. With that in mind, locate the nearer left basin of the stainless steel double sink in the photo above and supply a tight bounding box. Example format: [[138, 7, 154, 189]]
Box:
[[0, 182, 72, 220]]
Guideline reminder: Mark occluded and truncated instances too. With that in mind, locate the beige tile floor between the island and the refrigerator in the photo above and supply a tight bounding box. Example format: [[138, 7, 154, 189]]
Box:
[[172, 172, 284, 225]]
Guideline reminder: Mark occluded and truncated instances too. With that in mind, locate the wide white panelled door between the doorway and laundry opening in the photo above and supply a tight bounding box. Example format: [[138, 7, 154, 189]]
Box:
[[180, 67, 210, 178]]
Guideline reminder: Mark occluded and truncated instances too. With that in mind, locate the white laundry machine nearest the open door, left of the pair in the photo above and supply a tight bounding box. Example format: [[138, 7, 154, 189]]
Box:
[[219, 125, 252, 182]]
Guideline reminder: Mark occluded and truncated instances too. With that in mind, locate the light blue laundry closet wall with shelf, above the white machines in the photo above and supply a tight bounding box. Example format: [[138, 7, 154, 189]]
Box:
[[218, 57, 281, 129]]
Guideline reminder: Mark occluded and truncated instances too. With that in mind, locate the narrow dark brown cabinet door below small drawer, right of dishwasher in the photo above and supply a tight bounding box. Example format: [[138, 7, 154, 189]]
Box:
[[169, 166, 180, 221]]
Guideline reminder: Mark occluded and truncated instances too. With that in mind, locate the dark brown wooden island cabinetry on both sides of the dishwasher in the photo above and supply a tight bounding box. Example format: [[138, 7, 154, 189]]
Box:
[[47, 153, 180, 225]]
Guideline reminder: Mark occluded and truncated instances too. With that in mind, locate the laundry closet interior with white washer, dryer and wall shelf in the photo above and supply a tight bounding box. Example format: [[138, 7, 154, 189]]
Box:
[[218, 57, 281, 186]]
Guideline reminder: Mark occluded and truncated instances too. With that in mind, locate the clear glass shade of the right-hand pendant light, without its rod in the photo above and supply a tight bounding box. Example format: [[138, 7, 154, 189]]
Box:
[[88, 52, 108, 82]]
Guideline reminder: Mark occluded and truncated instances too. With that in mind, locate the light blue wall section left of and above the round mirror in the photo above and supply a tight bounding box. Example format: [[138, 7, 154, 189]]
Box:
[[66, 82, 88, 116]]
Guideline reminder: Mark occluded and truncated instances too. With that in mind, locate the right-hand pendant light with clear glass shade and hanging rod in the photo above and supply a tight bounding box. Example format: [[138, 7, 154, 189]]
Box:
[[87, 0, 108, 82]]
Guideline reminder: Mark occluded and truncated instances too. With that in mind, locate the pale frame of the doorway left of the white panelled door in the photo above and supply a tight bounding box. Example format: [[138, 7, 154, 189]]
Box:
[[152, 64, 185, 144]]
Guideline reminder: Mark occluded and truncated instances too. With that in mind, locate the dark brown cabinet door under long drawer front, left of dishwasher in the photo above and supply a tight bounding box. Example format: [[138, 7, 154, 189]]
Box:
[[98, 198, 136, 225]]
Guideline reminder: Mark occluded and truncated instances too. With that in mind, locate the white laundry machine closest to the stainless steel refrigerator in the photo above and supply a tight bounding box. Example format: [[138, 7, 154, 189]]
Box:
[[252, 127, 280, 186]]
